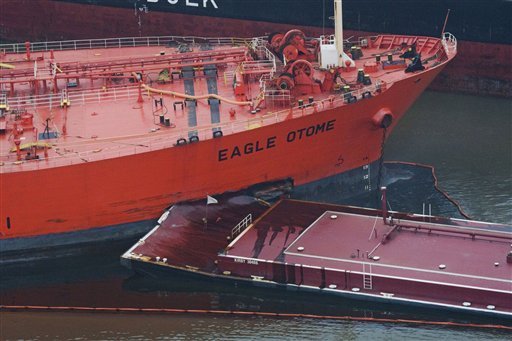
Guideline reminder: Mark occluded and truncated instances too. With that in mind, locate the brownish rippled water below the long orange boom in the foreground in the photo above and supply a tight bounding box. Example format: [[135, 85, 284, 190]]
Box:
[[2, 313, 507, 340]]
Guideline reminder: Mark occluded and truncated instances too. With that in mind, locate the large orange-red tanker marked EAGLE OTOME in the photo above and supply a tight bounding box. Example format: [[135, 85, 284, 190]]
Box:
[[0, 0, 457, 255]]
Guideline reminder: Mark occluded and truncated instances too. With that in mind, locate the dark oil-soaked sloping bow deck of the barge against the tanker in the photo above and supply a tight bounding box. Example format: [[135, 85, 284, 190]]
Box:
[[122, 195, 268, 273]]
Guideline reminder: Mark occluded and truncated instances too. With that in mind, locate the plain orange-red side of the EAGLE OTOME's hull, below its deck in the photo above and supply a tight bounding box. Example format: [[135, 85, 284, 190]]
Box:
[[1, 65, 444, 243]]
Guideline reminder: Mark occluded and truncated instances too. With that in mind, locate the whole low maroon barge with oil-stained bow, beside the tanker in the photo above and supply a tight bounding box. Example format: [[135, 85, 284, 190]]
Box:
[[122, 198, 512, 319]]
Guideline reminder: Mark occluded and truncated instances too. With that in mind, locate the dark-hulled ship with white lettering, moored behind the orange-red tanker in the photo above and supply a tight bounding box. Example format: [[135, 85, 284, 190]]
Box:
[[0, 0, 512, 97]]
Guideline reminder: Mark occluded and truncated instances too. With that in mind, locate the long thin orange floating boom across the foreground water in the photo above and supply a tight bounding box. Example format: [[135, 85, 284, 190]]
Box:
[[0, 305, 512, 331]]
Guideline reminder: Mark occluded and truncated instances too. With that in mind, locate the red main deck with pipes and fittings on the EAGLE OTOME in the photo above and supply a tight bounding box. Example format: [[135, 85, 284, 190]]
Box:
[[0, 32, 456, 173]]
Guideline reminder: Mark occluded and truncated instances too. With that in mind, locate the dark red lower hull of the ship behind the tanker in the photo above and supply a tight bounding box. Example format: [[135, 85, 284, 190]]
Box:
[[2, 0, 512, 97]]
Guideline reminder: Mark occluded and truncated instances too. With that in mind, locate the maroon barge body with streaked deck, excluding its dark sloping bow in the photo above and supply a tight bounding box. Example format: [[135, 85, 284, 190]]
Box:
[[218, 202, 512, 314]]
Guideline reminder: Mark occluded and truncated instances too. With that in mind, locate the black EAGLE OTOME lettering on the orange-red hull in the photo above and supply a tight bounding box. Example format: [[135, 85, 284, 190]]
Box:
[[217, 120, 336, 162]]
